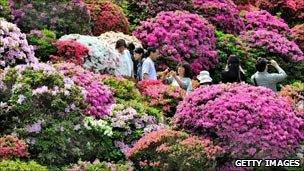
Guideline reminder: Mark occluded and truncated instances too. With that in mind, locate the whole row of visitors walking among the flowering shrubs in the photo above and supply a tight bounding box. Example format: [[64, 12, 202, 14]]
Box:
[[116, 39, 287, 92]]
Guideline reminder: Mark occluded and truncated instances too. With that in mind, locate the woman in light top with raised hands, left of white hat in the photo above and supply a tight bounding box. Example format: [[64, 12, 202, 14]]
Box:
[[163, 63, 192, 92]]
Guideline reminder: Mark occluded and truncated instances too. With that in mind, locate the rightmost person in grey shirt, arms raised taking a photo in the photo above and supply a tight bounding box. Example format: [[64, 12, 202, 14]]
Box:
[[251, 58, 287, 92]]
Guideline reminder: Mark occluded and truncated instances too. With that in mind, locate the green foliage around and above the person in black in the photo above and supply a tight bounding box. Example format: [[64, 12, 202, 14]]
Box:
[[210, 31, 255, 83]]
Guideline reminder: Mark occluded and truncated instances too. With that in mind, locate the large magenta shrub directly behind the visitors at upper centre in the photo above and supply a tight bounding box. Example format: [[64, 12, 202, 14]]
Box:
[[133, 11, 217, 74]]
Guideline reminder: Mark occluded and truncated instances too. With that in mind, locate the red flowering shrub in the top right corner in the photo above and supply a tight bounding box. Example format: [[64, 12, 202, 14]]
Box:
[[256, 0, 304, 25]]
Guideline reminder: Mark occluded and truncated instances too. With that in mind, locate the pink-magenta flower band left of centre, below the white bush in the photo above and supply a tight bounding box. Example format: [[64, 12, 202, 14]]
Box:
[[55, 63, 115, 118]]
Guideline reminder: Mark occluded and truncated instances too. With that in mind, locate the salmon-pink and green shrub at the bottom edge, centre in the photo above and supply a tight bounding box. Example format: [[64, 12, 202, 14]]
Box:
[[127, 129, 221, 170]]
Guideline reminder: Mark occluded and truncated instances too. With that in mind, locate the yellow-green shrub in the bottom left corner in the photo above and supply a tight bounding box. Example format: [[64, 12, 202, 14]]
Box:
[[0, 160, 48, 171]]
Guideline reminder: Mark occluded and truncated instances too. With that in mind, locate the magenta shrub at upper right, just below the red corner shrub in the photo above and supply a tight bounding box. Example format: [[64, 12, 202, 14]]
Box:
[[244, 10, 291, 37]]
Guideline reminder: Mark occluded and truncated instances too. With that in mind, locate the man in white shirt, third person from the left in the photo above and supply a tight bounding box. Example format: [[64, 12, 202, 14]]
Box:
[[142, 47, 159, 80]]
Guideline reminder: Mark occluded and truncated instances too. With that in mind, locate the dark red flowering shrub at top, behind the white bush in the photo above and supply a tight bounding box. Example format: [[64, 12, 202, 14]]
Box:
[[85, 0, 129, 36]]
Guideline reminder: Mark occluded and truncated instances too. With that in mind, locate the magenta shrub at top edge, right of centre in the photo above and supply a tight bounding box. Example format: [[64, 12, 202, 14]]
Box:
[[193, 0, 245, 35]]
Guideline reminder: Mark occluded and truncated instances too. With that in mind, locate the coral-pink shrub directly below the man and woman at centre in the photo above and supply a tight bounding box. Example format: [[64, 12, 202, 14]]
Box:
[[138, 80, 185, 116]]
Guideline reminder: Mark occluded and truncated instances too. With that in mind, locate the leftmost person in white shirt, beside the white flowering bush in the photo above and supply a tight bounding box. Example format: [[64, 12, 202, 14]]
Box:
[[115, 39, 133, 78]]
